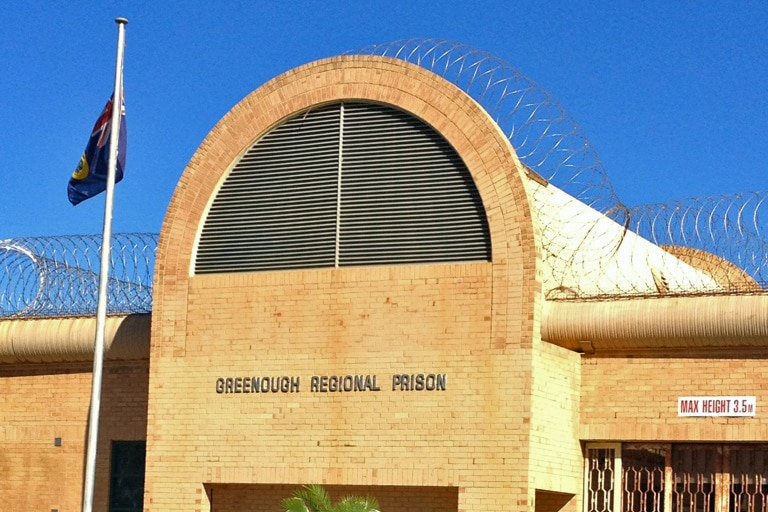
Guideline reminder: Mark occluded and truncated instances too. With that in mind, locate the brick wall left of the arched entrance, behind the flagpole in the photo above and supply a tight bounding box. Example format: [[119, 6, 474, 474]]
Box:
[[0, 361, 148, 512]]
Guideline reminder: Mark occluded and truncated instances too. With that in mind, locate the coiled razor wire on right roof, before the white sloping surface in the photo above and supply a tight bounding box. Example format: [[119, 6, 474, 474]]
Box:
[[535, 188, 768, 300]]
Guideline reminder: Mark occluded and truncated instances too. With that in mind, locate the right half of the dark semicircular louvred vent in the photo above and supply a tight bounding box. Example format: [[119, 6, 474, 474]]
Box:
[[339, 104, 490, 266]]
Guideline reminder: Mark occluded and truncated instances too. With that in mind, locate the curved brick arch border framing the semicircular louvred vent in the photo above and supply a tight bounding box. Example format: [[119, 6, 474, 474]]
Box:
[[152, 56, 538, 355]]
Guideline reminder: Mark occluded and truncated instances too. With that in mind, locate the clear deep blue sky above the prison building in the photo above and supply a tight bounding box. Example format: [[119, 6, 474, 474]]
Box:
[[0, 0, 768, 239]]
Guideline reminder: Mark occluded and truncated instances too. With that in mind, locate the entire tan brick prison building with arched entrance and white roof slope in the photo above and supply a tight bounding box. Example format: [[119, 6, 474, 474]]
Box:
[[0, 47, 768, 512]]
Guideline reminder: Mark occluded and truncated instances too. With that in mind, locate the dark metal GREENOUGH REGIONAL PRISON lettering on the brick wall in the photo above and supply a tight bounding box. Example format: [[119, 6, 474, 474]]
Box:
[[216, 373, 448, 394]]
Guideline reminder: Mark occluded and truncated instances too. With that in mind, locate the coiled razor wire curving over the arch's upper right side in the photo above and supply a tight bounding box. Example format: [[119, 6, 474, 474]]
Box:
[[350, 39, 626, 218]]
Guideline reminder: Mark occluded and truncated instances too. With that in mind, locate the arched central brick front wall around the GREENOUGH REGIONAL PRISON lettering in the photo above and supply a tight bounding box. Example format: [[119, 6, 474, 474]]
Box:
[[145, 57, 552, 511]]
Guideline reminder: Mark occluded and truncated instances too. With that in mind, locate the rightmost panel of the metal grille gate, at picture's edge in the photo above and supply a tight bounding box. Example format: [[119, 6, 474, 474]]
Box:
[[728, 446, 768, 512]]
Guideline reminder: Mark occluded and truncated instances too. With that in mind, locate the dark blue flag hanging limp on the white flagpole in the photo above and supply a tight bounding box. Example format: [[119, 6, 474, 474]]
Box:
[[67, 97, 128, 205]]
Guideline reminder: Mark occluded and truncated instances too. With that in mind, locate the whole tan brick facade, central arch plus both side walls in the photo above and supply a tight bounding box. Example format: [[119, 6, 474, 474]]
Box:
[[0, 56, 768, 512]]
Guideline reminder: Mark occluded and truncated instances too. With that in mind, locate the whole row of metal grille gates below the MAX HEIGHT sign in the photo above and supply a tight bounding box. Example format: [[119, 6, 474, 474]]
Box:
[[585, 443, 768, 512]]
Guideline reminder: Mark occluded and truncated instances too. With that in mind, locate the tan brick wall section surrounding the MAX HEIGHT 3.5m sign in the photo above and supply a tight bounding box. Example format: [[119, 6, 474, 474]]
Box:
[[581, 352, 768, 441]]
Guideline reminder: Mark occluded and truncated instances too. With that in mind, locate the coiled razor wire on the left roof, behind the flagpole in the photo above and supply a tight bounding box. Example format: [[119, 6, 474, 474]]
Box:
[[0, 233, 158, 318]]
